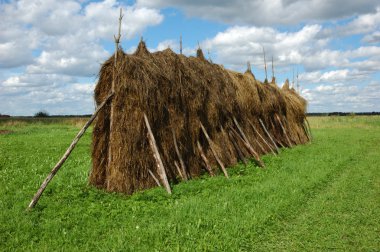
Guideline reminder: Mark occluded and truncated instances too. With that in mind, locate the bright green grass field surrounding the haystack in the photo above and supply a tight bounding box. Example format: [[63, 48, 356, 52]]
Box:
[[0, 116, 380, 251]]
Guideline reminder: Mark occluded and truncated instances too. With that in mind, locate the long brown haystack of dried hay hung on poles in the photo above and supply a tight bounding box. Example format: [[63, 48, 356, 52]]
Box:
[[90, 42, 307, 194]]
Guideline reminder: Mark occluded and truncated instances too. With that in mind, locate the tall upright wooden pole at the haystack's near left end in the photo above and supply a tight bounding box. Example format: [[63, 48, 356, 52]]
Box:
[[108, 8, 123, 176]]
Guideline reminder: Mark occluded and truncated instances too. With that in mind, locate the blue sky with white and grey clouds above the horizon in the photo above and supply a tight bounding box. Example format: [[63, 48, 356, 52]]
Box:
[[0, 0, 380, 115]]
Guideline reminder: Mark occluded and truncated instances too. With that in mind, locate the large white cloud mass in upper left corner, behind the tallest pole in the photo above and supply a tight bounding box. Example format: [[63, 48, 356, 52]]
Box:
[[0, 0, 163, 70]]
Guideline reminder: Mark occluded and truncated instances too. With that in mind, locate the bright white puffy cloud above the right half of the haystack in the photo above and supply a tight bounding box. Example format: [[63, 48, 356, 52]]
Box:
[[201, 25, 325, 70]]
